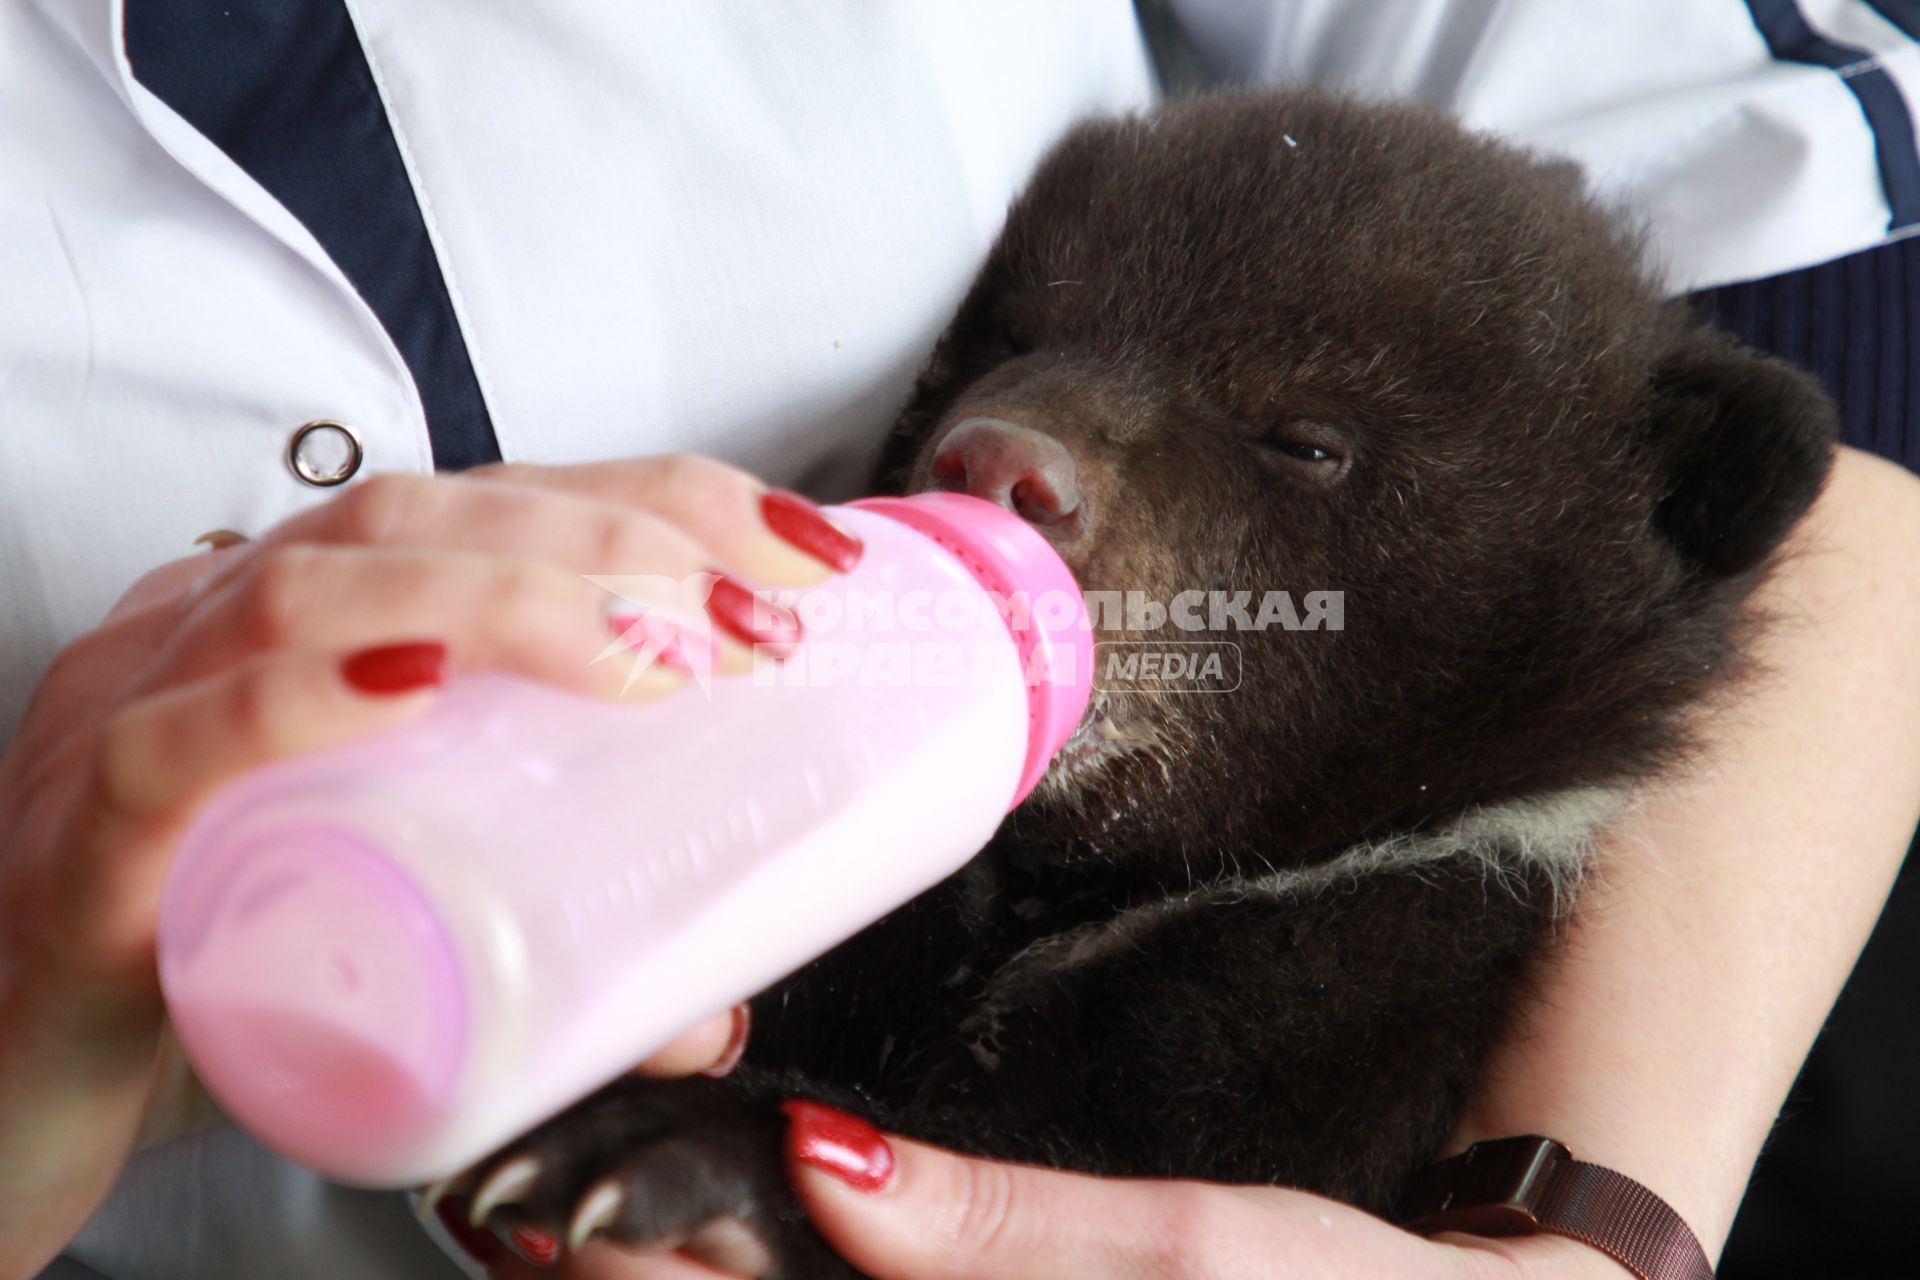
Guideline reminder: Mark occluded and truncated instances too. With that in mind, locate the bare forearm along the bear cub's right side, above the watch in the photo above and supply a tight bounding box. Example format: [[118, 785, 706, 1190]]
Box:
[[1457, 449, 1920, 1257]]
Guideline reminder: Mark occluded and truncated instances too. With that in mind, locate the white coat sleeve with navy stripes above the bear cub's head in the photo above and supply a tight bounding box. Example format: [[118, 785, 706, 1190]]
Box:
[[1177, 0, 1920, 292]]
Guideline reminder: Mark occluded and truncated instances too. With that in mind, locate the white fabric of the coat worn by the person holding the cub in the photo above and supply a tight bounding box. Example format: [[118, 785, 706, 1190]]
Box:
[[0, 0, 1916, 1280]]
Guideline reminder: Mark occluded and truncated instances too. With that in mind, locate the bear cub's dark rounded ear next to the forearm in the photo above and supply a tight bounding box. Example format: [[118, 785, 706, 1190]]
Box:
[[1649, 326, 1837, 578]]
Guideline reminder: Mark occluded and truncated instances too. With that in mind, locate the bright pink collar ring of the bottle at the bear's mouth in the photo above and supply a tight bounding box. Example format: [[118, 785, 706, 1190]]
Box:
[[847, 493, 1092, 810]]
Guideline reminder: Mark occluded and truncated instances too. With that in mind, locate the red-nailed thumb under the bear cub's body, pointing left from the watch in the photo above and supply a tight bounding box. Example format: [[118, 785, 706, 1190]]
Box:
[[787, 1103, 1466, 1280]]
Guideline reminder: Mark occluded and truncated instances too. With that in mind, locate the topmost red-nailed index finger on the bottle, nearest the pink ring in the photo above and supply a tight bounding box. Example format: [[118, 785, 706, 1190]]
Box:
[[461, 453, 860, 585]]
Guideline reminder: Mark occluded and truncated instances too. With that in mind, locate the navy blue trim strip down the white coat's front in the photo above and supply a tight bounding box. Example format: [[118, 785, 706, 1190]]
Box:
[[127, 0, 499, 470]]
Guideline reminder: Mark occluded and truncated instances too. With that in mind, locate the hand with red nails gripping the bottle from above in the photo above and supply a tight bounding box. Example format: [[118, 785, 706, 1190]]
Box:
[[0, 457, 858, 1276]]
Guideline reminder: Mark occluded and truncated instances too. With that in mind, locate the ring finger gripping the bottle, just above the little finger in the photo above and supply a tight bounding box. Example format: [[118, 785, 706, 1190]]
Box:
[[140, 543, 721, 700]]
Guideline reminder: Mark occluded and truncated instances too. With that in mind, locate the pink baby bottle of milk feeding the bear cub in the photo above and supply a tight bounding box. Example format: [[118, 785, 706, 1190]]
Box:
[[159, 493, 1092, 1186]]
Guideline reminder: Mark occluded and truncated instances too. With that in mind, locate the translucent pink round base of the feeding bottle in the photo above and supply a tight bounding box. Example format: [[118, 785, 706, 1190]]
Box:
[[159, 825, 467, 1180]]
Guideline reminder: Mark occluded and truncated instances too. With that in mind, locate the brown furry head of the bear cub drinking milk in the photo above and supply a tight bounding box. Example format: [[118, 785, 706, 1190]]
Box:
[[883, 92, 1834, 877]]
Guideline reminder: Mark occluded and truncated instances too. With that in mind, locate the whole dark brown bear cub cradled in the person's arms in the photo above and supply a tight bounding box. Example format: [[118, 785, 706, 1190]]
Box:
[[460, 92, 1832, 1278]]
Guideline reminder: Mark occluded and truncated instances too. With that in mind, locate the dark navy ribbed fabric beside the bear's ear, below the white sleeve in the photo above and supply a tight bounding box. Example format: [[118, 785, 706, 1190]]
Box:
[[1697, 236, 1920, 470]]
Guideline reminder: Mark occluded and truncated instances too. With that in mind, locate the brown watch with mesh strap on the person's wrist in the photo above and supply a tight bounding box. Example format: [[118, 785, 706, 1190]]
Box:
[[1398, 1136, 1713, 1280]]
